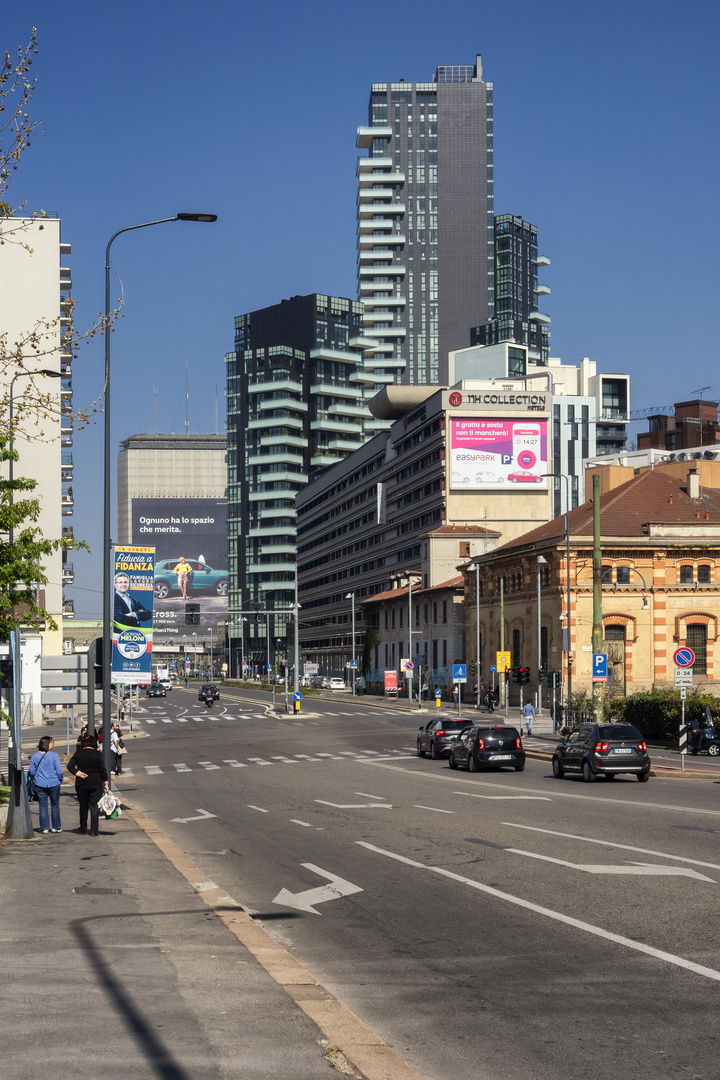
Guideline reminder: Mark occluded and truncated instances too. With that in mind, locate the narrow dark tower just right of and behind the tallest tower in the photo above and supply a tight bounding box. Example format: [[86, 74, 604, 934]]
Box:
[[471, 214, 551, 366]]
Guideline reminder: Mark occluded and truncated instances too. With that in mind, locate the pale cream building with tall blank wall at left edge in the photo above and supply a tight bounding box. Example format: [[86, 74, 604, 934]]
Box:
[[0, 217, 73, 721]]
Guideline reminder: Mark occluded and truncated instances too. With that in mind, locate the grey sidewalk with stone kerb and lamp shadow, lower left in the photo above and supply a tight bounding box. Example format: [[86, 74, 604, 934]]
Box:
[[0, 784, 420, 1080]]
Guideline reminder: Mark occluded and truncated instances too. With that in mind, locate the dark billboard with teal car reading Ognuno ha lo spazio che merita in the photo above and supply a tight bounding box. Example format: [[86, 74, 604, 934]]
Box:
[[132, 499, 229, 645]]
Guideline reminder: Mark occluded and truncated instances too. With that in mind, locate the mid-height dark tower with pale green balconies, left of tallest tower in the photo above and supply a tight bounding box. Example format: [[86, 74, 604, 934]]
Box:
[[226, 294, 375, 674]]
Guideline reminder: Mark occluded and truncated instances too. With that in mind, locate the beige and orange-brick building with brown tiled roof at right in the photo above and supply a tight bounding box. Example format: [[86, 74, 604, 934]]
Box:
[[464, 462, 720, 693]]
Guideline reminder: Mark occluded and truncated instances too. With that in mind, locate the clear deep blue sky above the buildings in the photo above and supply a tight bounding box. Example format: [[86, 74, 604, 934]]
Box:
[[0, 0, 720, 618]]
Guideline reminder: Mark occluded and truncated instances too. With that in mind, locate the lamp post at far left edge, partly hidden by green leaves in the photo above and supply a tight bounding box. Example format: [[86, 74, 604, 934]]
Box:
[[5, 367, 63, 840]]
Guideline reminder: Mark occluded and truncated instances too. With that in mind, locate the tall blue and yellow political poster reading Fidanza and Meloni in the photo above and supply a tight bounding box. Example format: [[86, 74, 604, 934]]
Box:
[[111, 546, 155, 684]]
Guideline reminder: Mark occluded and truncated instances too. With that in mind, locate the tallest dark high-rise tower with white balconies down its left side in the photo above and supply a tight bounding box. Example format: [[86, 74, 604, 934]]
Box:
[[357, 56, 494, 389]]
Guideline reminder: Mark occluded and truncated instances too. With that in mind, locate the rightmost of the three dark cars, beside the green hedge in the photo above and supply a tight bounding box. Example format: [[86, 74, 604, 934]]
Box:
[[553, 723, 650, 784]]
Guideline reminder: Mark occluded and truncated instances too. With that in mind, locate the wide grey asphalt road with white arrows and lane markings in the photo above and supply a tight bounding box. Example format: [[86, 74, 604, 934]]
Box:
[[118, 689, 720, 1080]]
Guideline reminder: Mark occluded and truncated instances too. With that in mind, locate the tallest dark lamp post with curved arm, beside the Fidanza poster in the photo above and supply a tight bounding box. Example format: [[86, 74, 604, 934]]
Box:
[[103, 214, 217, 775]]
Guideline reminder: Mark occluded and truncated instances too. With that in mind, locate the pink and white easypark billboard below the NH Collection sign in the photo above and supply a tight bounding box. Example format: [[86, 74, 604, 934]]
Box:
[[450, 417, 548, 490]]
